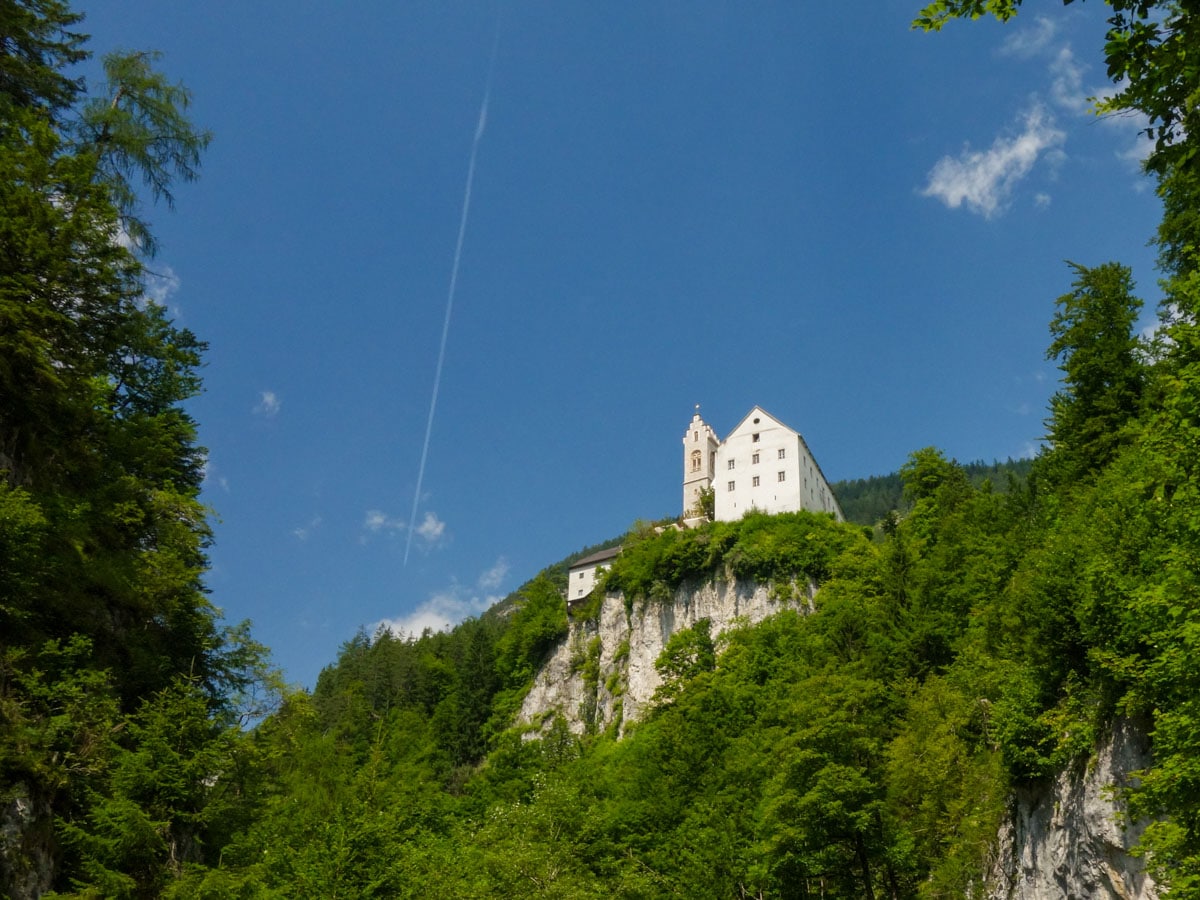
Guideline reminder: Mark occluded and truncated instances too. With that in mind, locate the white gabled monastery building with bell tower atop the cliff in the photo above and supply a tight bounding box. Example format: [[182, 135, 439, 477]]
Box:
[[683, 406, 844, 524]]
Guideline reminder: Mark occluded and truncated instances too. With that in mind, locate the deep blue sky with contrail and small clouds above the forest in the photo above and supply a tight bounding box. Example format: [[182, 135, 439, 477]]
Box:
[[80, 0, 1159, 685]]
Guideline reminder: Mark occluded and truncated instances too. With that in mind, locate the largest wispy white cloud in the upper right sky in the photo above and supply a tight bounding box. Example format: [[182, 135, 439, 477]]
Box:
[[922, 104, 1067, 218]]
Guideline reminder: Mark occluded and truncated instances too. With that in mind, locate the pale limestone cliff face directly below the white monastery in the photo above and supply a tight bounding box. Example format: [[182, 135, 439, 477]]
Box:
[[518, 581, 815, 733]]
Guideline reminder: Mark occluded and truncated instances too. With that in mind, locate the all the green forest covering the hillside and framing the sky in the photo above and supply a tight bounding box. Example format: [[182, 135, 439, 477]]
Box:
[[0, 0, 1200, 899]]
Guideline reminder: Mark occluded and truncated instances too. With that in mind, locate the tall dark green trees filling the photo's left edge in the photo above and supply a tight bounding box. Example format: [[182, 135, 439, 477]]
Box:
[[0, 0, 265, 898]]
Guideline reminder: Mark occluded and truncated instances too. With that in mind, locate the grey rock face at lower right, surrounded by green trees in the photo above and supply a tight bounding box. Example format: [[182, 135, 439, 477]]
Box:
[[985, 720, 1159, 900]]
